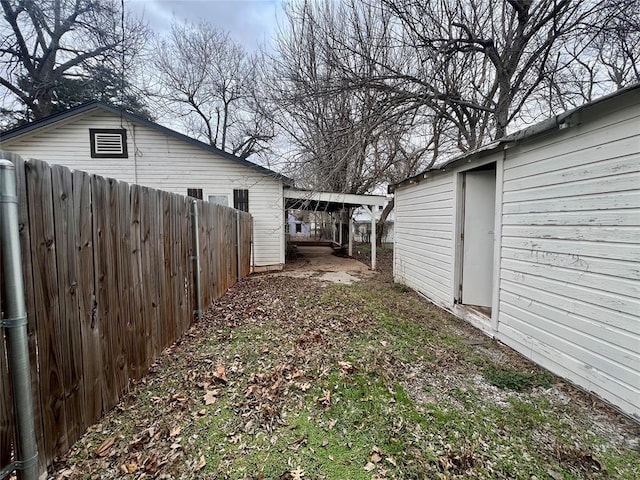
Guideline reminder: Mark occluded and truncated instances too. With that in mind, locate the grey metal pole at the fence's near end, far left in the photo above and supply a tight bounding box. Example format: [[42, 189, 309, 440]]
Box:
[[0, 160, 38, 480]]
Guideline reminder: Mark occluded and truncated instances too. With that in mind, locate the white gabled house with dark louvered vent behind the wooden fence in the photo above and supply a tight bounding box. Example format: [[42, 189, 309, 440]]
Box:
[[0, 102, 292, 270]]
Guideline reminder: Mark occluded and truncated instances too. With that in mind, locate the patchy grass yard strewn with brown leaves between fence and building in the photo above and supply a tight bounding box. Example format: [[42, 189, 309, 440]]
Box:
[[51, 249, 640, 480]]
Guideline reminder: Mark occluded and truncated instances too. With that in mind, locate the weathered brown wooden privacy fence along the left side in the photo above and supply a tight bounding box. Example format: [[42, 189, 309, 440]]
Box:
[[0, 154, 252, 468]]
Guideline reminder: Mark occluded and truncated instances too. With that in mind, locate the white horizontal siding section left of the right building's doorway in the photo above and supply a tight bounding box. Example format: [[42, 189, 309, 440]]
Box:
[[394, 173, 454, 306]]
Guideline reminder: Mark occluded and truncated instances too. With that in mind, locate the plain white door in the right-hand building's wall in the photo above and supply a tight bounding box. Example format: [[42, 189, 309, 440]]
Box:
[[462, 170, 496, 307]]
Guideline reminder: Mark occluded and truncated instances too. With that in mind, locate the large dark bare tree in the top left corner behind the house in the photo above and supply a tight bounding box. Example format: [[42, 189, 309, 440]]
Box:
[[0, 0, 147, 120]]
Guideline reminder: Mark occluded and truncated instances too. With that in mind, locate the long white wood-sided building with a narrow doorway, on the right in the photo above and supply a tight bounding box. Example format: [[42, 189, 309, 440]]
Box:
[[392, 85, 640, 419]]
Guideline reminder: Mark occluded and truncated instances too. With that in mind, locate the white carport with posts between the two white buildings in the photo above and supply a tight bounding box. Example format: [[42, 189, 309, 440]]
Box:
[[284, 188, 387, 270]]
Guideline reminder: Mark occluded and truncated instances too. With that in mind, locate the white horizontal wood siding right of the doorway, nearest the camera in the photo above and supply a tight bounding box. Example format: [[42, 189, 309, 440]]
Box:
[[498, 100, 640, 416]]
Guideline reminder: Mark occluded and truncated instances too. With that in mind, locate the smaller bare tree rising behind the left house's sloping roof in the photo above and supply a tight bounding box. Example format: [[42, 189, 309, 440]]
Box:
[[153, 21, 272, 158]]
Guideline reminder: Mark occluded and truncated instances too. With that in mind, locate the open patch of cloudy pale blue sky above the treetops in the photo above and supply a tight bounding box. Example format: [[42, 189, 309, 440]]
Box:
[[125, 0, 283, 50]]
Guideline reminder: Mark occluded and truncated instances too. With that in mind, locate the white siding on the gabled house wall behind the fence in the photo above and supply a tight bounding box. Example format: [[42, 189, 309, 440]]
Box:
[[0, 111, 284, 267]]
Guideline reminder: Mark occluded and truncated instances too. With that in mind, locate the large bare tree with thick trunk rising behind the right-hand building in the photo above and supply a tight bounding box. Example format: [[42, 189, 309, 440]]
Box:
[[376, 0, 632, 147]]
